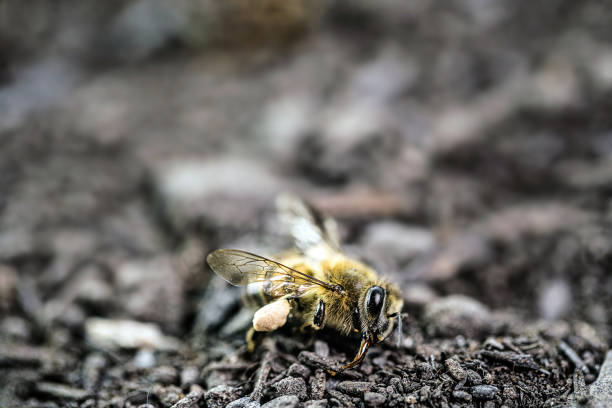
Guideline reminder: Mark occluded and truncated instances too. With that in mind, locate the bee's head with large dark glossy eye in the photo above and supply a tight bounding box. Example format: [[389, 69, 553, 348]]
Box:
[[354, 285, 402, 344]]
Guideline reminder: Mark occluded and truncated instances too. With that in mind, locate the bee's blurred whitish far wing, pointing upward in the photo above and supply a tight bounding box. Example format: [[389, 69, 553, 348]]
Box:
[[276, 193, 341, 260]]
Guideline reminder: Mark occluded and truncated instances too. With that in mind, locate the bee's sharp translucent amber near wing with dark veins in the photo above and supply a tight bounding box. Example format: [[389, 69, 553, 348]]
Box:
[[206, 249, 343, 294]]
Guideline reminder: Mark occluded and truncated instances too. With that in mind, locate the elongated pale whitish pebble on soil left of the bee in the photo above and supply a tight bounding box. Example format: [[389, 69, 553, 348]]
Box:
[[85, 317, 179, 350]]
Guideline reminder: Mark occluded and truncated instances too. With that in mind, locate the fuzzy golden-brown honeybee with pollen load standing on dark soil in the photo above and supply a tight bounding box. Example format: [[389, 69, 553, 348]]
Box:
[[206, 194, 403, 375]]
